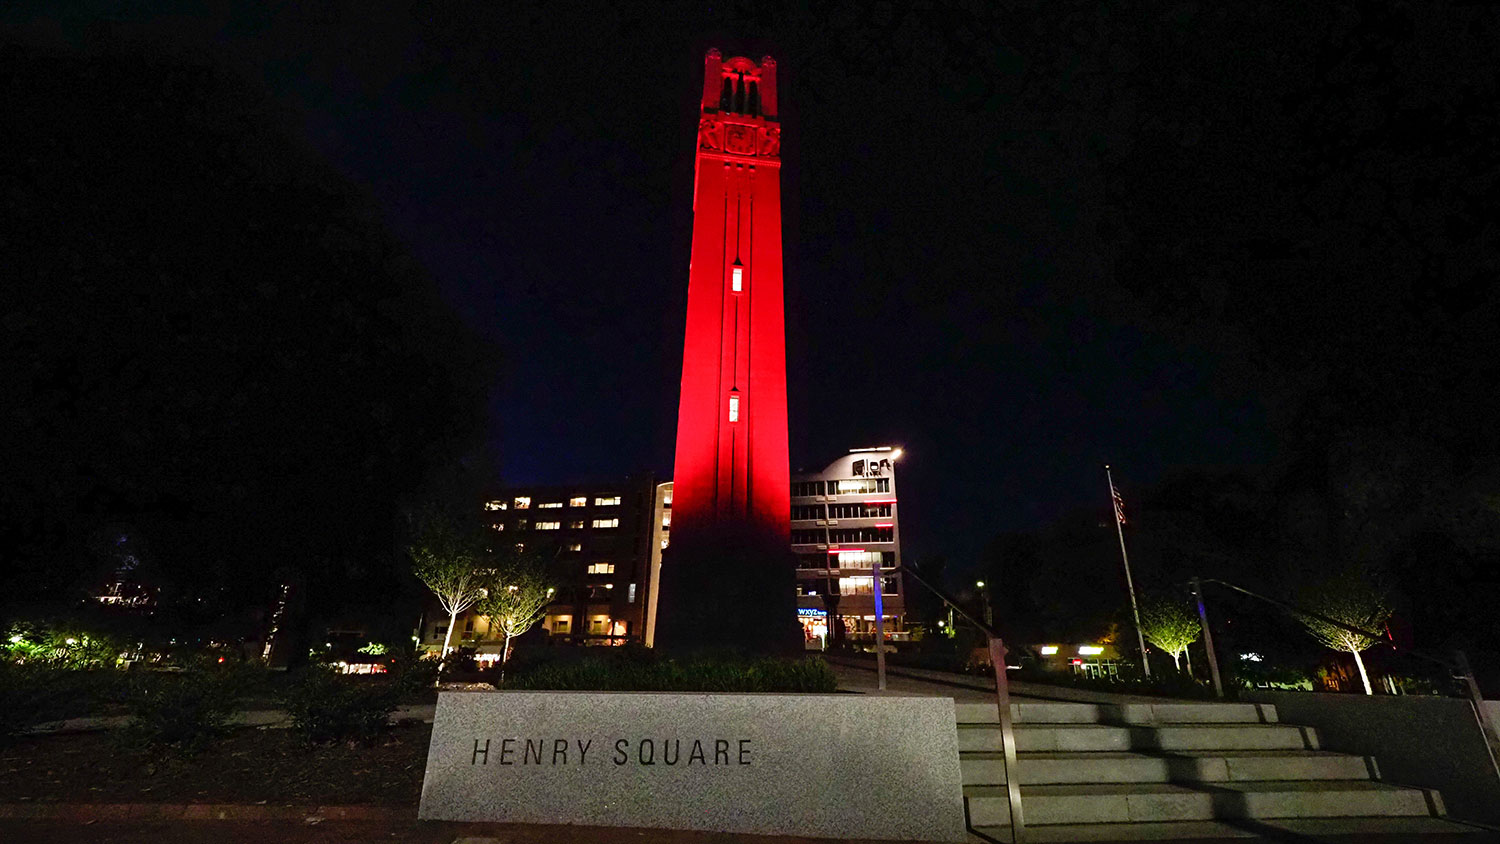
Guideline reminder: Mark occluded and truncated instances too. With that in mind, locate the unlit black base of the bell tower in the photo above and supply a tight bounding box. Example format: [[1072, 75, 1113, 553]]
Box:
[[656, 526, 804, 657]]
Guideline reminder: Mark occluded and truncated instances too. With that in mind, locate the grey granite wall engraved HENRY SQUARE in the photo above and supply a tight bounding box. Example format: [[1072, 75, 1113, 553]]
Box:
[[419, 691, 965, 841]]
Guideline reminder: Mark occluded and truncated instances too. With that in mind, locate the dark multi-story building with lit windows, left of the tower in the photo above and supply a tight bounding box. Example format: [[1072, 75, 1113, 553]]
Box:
[[422, 474, 657, 660]]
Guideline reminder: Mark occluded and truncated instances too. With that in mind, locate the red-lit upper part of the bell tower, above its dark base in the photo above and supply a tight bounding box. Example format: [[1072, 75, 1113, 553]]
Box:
[[672, 49, 791, 547]]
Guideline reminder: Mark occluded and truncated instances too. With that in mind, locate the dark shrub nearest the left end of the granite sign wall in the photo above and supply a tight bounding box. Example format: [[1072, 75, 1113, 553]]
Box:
[[281, 664, 437, 744]]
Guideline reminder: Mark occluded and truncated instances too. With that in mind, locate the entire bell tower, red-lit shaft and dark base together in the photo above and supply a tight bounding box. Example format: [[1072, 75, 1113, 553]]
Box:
[[656, 49, 803, 652]]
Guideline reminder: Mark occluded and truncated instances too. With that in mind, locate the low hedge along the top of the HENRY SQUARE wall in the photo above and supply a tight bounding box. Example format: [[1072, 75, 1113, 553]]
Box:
[[506, 657, 839, 693]]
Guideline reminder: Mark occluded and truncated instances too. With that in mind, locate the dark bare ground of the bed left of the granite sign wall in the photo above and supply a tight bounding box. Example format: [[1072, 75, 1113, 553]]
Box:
[[0, 724, 432, 814]]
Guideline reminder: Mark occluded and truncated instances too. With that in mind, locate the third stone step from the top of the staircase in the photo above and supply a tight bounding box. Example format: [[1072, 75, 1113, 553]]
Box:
[[959, 750, 1374, 786]]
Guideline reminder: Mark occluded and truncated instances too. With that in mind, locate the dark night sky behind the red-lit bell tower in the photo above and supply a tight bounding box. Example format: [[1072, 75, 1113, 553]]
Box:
[[8, 1, 1314, 562]]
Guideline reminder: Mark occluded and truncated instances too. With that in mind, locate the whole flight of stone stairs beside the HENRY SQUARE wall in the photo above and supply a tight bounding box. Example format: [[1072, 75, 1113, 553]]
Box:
[[954, 702, 1476, 841]]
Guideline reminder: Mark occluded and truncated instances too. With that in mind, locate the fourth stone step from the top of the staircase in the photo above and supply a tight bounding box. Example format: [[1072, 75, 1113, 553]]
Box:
[[963, 780, 1443, 828]]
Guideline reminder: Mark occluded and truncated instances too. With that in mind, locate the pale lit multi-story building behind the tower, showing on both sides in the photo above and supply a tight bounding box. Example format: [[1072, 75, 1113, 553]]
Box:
[[645, 447, 906, 649]]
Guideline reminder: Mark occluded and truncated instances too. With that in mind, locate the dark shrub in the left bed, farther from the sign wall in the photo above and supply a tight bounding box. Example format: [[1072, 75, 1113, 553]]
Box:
[[125, 669, 251, 753]]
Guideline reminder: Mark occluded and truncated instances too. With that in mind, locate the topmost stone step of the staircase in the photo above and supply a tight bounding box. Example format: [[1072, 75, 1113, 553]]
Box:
[[954, 702, 1277, 724]]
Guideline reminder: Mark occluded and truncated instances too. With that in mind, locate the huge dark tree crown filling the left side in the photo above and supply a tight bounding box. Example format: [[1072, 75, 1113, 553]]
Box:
[[0, 45, 492, 634]]
